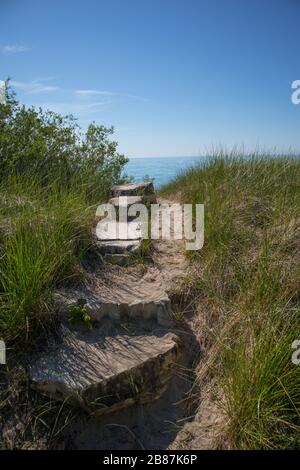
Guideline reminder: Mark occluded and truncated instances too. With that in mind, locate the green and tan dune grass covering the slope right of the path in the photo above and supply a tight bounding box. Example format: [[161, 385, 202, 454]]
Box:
[[162, 152, 300, 449]]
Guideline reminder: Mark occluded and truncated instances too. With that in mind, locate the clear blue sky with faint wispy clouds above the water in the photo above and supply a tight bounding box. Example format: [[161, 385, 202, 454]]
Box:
[[0, 0, 300, 157]]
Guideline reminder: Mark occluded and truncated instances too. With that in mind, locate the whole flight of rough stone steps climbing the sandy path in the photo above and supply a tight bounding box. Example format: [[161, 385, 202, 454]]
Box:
[[29, 183, 182, 414]]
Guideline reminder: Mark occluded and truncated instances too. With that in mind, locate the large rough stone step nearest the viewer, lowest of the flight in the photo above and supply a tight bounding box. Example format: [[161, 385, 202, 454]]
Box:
[[29, 321, 179, 414]]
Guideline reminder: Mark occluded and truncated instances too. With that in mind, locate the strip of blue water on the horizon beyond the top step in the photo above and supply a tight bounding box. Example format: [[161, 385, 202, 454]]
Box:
[[124, 157, 205, 188]]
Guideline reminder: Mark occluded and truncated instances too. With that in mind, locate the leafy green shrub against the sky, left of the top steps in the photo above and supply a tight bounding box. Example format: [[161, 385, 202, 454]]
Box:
[[0, 82, 127, 200]]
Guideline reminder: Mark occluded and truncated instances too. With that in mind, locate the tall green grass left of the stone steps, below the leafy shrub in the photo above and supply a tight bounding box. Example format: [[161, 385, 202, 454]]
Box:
[[0, 176, 97, 340]]
